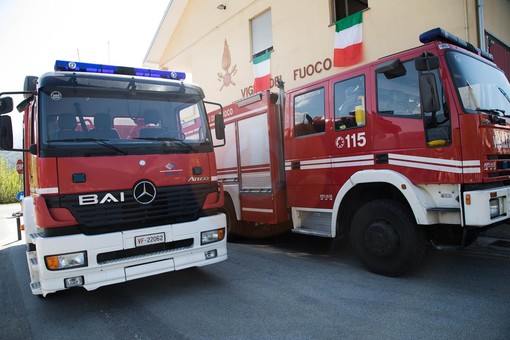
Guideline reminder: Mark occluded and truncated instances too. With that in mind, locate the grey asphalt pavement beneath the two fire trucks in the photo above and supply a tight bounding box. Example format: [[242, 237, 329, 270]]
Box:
[[0, 204, 510, 340]]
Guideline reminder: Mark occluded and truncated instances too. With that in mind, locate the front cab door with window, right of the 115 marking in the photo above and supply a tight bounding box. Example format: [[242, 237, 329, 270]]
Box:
[[372, 54, 456, 183]]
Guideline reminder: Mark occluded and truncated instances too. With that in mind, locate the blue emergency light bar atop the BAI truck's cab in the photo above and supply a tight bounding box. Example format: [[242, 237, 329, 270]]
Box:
[[55, 60, 186, 80]]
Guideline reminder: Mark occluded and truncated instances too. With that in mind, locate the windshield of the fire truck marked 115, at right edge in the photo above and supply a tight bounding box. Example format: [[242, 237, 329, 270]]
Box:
[[446, 51, 510, 115]]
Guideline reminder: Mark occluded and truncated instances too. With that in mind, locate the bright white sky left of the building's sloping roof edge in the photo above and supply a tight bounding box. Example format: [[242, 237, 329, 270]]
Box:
[[0, 0, 171, 144]]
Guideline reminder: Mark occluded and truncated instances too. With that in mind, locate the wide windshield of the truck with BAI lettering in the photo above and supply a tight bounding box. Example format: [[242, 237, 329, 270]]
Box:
[[38, 74, 211, 157]]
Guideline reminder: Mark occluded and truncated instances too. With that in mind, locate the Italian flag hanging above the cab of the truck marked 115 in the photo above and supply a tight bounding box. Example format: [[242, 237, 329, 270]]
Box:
[[333, 12, 362, 67]]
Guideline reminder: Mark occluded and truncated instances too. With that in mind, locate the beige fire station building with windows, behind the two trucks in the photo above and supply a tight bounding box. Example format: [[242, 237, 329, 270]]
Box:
[[144, 0, 510, 104]]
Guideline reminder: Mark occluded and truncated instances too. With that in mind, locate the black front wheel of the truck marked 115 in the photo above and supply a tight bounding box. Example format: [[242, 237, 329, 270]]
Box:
[[350, 199, 426, 276]]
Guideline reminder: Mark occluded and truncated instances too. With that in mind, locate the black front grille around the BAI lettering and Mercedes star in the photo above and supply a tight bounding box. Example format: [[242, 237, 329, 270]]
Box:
[[46, 184, 217, 234]]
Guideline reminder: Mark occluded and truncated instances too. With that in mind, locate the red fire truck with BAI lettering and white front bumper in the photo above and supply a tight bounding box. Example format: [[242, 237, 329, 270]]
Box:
[[0, 61, 227, 296]]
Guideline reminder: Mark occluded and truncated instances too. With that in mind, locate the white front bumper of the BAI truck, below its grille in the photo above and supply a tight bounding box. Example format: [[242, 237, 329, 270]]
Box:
[[27, 214, 227, 295]]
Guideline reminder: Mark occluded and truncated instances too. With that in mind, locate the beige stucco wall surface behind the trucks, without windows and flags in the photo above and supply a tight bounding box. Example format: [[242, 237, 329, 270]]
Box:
[[149, 0, 510, 104]]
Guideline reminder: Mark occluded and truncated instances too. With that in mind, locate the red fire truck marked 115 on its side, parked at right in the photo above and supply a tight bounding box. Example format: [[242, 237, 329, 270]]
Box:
[[210, 28, 510, 276]]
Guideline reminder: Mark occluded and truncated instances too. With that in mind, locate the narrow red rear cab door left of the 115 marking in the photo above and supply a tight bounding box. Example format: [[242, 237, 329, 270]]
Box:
[[285, 82, 333, 209]]
